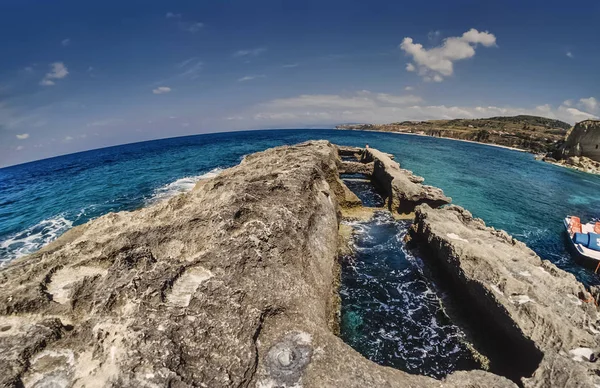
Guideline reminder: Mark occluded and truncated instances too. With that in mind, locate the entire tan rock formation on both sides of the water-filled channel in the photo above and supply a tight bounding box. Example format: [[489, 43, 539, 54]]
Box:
[[0, 141, 600, 388]]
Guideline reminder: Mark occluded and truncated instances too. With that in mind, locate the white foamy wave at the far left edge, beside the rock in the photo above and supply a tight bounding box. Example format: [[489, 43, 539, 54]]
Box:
[[0, 215, 73, 263]]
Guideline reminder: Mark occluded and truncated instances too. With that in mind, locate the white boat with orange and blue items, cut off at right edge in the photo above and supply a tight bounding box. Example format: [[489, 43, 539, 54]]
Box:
[[564, 216, 600, 273]]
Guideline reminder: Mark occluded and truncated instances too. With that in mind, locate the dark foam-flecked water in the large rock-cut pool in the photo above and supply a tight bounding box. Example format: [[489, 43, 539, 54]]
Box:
[[340, 211, 479, 378]]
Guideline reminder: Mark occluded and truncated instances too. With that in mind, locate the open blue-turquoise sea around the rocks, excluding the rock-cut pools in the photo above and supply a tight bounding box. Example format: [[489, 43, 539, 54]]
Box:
[[0, 130, 600, 284]]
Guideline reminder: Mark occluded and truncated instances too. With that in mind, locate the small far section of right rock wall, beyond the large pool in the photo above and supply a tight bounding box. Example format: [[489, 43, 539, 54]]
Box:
[[361, 148, 452, 214]]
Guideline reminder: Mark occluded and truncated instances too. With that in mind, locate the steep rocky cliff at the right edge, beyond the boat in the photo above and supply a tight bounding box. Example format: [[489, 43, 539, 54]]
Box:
[[555, 120, 600, 162]]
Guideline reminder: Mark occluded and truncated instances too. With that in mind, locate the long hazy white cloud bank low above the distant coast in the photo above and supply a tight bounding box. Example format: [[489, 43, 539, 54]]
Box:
[[238, 91, 596, 127]]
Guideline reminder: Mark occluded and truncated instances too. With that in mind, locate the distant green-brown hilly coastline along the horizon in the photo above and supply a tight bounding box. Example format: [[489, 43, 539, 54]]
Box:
[[336, 115, 571, 152]]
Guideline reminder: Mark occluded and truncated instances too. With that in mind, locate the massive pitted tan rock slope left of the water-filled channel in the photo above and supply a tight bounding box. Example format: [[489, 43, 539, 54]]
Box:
[[0, 142, 512, 388]]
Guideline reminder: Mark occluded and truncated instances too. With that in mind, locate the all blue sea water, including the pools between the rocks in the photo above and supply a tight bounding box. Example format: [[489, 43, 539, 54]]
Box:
[[0, 129, 600, 378]]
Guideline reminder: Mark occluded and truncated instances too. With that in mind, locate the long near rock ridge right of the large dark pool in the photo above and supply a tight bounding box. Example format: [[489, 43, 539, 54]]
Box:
[[411, 205, 600, 388]]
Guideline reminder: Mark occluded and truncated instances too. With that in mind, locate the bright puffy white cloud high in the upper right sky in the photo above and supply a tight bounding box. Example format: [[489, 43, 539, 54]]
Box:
[[400, 28, 496, 82]]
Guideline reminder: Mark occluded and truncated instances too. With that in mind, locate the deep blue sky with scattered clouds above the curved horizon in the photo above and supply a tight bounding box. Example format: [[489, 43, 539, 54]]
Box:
[[0, 0, 600, 167]]
